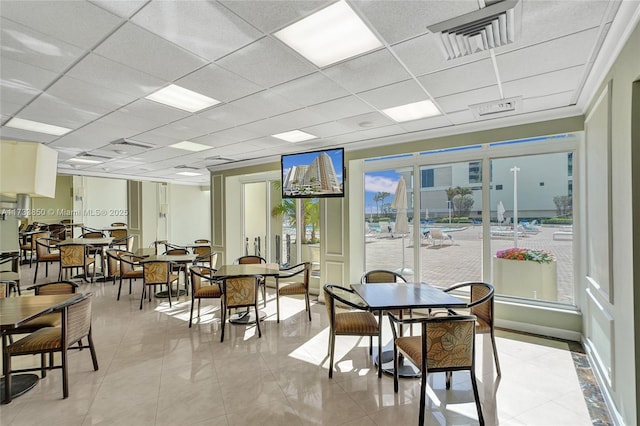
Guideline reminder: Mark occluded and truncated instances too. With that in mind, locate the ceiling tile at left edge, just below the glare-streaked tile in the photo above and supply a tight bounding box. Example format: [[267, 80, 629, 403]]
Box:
[[0, 58, 56, 104]]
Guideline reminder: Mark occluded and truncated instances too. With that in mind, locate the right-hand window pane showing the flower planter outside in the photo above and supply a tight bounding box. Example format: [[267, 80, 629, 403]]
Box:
[[490, 152, 574, 303]]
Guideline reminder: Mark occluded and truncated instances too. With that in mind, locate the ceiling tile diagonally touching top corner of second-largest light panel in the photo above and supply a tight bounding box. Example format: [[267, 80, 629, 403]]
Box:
[[94, 23, 207, 81]]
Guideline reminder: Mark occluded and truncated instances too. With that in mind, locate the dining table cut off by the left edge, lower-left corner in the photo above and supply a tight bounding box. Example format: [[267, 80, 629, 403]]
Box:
[[0, 294, 82, 403]]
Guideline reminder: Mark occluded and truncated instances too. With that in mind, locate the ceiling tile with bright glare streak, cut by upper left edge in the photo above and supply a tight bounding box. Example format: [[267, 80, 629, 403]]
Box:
[[0, 17, 85, 72]]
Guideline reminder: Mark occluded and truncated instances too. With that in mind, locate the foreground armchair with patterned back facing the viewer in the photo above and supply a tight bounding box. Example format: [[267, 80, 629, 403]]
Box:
[[388, 313, 484, 425]]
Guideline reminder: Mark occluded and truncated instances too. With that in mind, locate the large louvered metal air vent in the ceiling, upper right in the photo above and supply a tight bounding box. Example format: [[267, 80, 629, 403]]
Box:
[[427, 0, 521, 59]]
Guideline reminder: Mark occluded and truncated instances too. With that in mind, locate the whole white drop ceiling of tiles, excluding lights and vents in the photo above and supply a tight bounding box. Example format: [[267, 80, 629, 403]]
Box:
[[0, 0, 639, 184]]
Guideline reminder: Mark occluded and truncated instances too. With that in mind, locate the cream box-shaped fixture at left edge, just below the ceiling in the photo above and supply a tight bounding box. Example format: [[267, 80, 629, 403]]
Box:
[[0, 141, 58, 218]]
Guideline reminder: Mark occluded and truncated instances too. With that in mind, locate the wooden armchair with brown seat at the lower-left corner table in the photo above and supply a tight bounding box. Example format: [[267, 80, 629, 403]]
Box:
[[4, 293, 98, 403]]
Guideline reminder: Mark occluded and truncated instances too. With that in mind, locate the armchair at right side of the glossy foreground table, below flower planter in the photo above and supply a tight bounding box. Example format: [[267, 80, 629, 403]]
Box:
[[444, 281, 502, 376]]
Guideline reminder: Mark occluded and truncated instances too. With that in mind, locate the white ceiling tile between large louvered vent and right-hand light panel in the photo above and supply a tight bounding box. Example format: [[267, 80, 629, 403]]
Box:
[[418, 59, 498, 97]]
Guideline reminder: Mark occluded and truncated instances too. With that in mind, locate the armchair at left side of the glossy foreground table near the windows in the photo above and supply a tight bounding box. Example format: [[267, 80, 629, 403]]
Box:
[[323, 284, 380, 378]]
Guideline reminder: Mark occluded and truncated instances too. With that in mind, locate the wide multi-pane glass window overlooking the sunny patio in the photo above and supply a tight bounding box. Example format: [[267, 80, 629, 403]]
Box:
[[364, 135, 579, 305]]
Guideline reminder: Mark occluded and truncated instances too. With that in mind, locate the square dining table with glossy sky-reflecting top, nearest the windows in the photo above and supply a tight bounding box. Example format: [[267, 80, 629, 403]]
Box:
[[351, 282, 467, 377]]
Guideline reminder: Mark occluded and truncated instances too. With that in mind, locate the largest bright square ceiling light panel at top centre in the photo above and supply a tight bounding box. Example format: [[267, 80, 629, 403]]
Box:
[[275, 1, 382, 67]]
